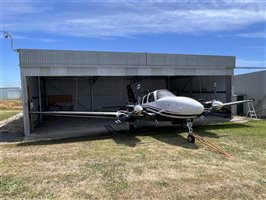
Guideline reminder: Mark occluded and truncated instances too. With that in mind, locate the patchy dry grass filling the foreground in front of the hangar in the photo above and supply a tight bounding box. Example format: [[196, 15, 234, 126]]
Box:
[[0, 121, 266, 199]]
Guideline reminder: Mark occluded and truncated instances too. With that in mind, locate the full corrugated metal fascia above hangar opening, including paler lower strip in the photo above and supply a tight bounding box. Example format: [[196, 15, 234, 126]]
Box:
[[19, 49, 235, 76]]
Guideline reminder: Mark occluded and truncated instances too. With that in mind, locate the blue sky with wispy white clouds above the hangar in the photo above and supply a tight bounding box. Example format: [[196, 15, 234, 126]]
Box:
[[0, 0, 266, 87]]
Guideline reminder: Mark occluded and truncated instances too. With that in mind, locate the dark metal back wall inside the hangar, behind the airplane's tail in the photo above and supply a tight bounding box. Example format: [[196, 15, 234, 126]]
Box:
[[43, 77, 166, 111]]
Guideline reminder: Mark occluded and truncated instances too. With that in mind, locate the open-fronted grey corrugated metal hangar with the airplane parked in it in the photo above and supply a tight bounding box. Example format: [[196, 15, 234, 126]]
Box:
[[18, 49, 235, 136]]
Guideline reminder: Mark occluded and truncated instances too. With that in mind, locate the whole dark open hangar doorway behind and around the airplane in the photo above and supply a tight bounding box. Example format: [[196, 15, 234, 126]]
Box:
[[26, 76, 231, 138]]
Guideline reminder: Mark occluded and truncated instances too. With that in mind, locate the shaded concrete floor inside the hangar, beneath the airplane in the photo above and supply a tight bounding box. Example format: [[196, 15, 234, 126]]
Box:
[[26, 116, 231, 140]]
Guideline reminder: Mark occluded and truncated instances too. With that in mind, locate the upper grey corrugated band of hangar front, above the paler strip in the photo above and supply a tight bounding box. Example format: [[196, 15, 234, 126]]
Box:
[[19, 49, 235, 68]]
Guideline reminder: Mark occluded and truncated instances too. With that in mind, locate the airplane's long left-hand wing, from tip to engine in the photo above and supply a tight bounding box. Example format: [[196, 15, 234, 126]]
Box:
[[30, 111, 119, 118]]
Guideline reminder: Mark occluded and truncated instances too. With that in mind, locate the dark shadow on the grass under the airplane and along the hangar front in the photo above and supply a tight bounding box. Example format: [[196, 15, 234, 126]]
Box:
[[17, 124, 248, 149]]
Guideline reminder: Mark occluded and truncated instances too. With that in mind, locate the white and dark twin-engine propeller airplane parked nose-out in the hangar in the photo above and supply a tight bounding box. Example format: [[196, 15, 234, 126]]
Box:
[[29, 84, 255, 143]]
